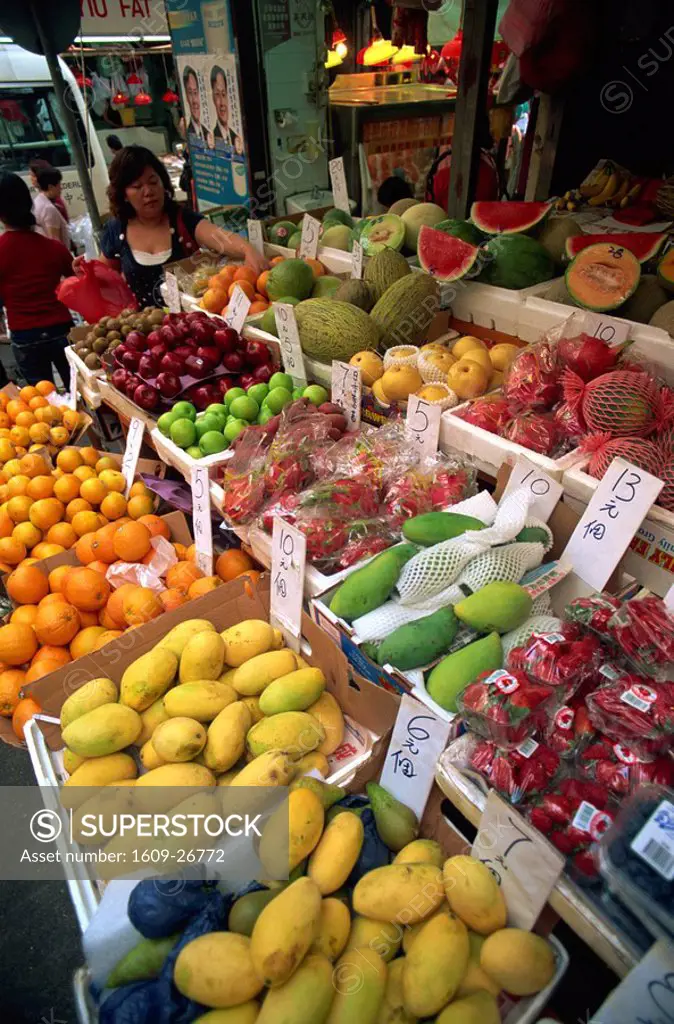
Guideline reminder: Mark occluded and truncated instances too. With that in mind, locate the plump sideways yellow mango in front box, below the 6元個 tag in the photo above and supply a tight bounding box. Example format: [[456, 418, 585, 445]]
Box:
[[353, 864, 445, 925]]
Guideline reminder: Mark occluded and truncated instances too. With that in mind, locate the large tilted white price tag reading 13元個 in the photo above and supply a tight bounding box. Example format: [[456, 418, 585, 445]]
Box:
[[561, 459, 663, 590]]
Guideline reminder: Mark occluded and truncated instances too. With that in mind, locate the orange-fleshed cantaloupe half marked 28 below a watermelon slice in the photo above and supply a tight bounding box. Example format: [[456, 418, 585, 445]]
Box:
[[565, 243, 641, 312]]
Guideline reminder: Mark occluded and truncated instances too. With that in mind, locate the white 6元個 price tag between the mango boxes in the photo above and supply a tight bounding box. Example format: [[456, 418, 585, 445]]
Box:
[[381, 693, 452, 818]]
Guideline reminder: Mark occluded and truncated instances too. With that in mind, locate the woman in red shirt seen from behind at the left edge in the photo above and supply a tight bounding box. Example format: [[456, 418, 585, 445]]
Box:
[[0, 174, 73, 387]]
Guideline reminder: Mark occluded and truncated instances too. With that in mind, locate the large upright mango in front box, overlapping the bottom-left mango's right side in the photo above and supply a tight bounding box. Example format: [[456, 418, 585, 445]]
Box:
[[250, 878, 321, 987]]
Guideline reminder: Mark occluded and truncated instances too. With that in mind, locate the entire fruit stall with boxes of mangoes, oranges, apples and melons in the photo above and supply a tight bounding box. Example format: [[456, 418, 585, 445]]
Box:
[[0, 186, 674, 1024]]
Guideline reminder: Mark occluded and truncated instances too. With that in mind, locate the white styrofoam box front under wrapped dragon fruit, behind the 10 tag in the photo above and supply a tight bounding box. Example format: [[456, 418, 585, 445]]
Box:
[[440, 402, 584, 480]]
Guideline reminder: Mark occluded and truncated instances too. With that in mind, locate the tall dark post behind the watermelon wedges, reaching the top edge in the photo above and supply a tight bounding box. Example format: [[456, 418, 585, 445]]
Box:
[[447, 0, 499, 219]]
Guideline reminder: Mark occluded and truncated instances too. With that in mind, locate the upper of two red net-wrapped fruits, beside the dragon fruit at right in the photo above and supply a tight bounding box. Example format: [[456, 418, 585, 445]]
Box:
[[561, 370, 674, 437]]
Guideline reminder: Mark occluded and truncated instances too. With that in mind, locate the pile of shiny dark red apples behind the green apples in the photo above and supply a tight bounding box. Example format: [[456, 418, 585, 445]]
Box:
[[107, 311, 273, 412]]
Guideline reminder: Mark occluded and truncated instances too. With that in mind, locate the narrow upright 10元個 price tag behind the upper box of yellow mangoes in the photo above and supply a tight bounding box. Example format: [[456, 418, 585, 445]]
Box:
[[269, 517, 306, 651]]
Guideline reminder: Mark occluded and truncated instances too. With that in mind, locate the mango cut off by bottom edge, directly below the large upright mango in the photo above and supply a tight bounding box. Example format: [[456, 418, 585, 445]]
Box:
[[255, 952, 334, 1024]]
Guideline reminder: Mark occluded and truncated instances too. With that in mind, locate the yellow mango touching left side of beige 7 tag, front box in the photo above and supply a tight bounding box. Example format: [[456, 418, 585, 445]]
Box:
[[443, 855, 508, 935]]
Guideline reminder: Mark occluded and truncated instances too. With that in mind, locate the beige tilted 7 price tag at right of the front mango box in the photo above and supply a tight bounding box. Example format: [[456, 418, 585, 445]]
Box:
[[471, 786, 564, 931]]
